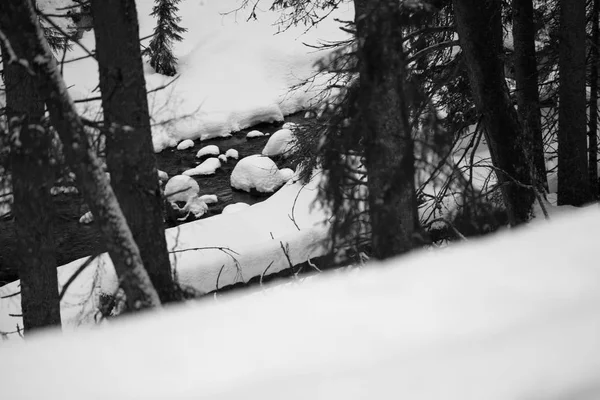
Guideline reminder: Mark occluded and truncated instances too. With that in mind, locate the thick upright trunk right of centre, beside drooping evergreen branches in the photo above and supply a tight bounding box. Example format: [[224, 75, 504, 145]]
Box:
[[354, 0, 418, 259]]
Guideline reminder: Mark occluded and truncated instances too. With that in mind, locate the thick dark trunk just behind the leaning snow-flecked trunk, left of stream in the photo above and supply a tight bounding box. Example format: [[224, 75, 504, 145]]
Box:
[[92, 0, 175, 302]]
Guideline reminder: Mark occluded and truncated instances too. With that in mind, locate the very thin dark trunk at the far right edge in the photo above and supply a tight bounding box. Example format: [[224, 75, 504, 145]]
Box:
[[588, 0, 600, 199]]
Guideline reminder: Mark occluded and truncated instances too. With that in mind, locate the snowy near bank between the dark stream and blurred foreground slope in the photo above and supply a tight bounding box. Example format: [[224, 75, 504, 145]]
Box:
[[0, 175, 328, 337]]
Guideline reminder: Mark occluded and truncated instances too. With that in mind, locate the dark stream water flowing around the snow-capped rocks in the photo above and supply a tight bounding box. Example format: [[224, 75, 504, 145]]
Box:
[[0, 116, 302, 285]]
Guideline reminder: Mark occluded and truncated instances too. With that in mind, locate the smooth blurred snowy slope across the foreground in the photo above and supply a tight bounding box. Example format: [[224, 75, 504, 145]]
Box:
[[0, 208, 600, 400]]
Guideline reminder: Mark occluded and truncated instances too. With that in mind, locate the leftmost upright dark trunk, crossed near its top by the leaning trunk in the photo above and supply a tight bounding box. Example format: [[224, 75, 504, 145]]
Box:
[[2, 46, 61, 334]]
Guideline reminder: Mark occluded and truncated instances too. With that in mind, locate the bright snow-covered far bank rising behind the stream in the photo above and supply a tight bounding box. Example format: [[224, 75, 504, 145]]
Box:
[[48, 0, 353, 151]]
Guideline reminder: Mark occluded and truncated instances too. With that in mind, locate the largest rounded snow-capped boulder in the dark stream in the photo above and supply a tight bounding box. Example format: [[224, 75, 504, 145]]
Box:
[[231, 154, 285, 193]]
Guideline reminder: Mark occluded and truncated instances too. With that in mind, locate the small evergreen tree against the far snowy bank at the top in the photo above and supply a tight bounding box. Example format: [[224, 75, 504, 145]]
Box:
[[143, 0, 187, 76]]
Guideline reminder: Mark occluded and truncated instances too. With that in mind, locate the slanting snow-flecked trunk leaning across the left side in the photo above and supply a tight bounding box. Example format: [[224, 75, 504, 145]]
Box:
[[0, 0, 160, 310]]
